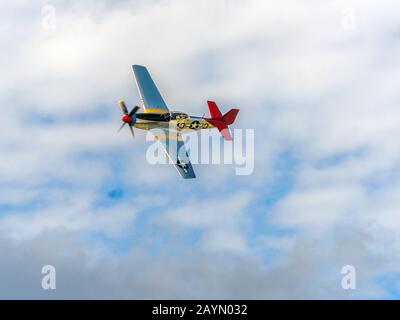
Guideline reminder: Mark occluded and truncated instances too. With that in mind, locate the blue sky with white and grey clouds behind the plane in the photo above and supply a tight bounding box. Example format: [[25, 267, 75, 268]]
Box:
[[0, 0, 400, 299]]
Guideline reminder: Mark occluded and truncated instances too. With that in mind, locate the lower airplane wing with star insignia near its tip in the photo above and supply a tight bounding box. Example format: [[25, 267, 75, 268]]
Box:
[[153, 128, 196, 179]]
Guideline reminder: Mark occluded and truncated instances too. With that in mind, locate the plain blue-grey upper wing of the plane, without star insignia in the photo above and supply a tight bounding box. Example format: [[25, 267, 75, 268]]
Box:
[[132, 65, 169, 113]]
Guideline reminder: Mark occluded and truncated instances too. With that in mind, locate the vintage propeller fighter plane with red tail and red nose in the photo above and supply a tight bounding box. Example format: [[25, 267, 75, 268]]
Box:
[[118, 65, 239, 179]]
